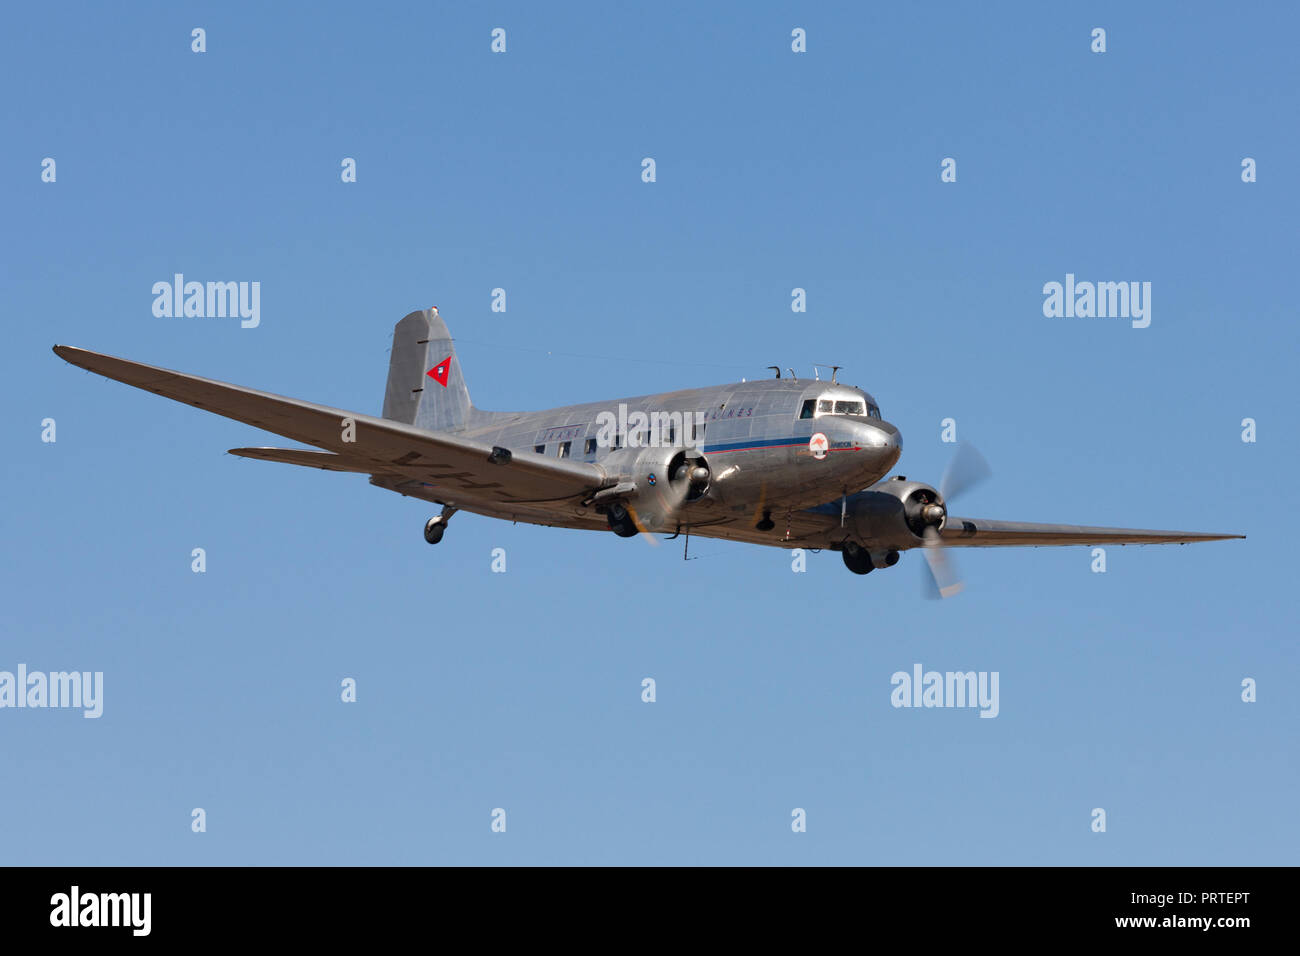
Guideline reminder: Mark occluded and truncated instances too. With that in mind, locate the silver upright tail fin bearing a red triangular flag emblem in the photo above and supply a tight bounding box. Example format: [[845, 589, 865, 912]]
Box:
[[384, 306, 471, 432]]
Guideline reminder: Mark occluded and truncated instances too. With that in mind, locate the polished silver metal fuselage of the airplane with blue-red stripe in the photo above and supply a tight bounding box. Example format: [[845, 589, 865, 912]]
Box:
[[374, 378, 902, 538]]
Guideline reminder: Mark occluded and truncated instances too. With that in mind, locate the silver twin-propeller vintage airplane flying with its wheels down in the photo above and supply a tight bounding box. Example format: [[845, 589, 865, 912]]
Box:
[[53, 307, 1245, 597]]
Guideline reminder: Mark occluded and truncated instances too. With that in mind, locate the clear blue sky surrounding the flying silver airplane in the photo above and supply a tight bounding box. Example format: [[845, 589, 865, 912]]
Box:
[[0, 3, 1300, 864]]
